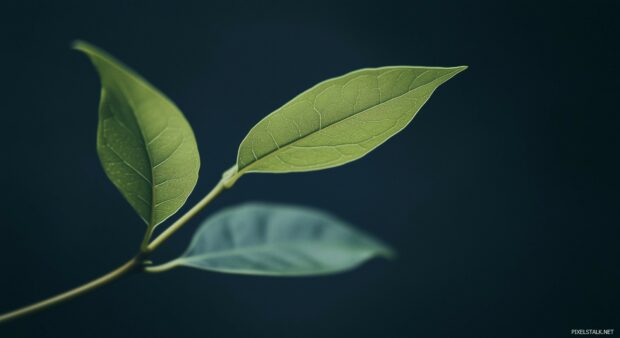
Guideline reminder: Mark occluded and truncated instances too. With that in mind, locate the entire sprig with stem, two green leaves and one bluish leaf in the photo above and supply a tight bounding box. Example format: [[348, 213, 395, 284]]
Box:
[[0, 41, 467, 323]]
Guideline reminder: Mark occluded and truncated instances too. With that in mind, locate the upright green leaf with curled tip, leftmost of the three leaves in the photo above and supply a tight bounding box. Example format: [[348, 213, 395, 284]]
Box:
[[73, 41, 200, 230]]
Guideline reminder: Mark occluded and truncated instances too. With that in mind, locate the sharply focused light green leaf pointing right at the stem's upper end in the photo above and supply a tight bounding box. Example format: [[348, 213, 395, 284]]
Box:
[[229, 66, 467, 185]]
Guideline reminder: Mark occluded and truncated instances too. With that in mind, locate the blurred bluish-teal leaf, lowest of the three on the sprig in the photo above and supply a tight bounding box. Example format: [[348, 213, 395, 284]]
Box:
[[159, 203, 392, 276]]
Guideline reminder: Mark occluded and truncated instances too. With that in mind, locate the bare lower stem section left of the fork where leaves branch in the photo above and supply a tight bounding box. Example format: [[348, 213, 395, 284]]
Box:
[[0, 257, 140, 323]]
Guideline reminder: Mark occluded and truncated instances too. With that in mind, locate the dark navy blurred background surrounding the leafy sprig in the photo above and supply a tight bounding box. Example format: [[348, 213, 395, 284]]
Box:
[[0, 0, 620, 338]]
